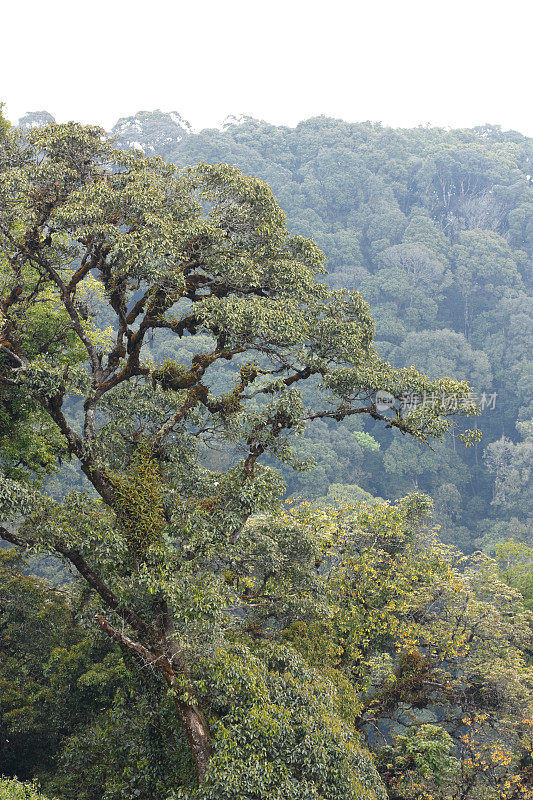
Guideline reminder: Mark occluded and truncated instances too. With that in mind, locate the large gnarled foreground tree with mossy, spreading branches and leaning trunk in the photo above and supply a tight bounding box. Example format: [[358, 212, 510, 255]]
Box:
[[0, 124, 475, 797]]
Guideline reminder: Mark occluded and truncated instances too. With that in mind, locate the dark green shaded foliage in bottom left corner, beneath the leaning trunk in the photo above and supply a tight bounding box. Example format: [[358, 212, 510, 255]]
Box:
[[0, 550, 192, 800]]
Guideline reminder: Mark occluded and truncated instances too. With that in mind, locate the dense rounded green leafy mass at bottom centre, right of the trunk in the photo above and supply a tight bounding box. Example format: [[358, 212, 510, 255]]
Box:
[[177, 644, 385, 800]]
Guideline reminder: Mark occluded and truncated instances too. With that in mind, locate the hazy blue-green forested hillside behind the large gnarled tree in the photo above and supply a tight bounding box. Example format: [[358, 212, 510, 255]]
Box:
[[106, 112, 533, 552]]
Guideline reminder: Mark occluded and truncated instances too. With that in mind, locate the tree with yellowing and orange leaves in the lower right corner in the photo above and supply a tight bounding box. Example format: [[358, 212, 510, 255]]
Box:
[[280, 494, 533, 800]]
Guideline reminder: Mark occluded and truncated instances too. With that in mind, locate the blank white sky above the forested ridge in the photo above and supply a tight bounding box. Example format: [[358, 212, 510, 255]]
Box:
[[0, 0, 533, 135]]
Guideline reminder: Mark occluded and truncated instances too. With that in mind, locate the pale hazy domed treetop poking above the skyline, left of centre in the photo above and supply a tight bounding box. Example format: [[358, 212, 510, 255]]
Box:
[[111, 111, 193, 158]]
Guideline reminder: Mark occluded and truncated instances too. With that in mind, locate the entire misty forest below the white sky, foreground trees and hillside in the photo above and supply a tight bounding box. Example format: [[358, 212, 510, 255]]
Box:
[[0, 111, 533, 800]]
